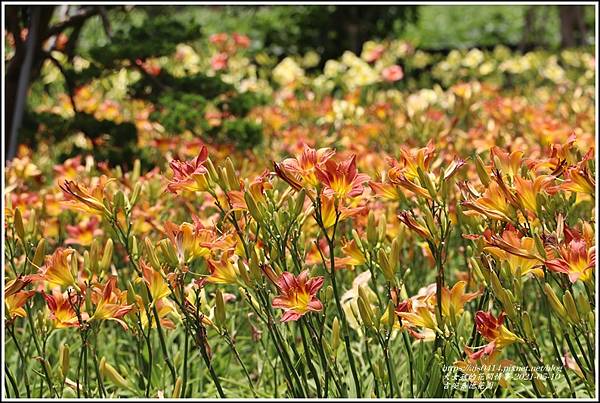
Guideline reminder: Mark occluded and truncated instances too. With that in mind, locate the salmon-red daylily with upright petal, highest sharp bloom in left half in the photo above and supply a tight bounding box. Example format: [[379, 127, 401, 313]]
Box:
[[167, 146, 208, 193]]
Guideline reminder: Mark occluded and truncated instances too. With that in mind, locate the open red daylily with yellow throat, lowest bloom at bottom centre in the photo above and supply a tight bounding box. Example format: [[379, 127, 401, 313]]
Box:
[[272, 270, 323, 322]]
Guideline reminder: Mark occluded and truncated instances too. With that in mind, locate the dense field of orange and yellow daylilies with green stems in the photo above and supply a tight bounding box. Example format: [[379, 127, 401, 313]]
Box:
[[4, 26, 597, 398]]
